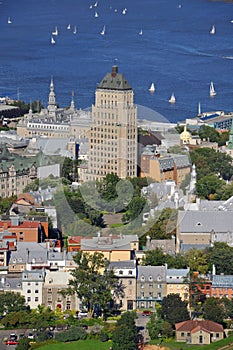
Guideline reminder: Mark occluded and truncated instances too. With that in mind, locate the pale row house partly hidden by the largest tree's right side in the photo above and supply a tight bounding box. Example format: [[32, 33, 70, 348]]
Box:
[[109, 260, 137, 310]]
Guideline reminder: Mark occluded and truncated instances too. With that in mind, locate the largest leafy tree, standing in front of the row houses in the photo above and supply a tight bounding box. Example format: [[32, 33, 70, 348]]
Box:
[[63, 251, 124, 318]]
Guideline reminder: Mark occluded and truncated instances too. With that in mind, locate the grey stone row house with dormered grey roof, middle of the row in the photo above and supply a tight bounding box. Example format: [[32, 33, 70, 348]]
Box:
[[136, 266, 167, 309]]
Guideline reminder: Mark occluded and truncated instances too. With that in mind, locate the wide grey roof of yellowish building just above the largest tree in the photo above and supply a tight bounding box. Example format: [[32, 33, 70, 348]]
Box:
[[81, 235, 138, 250]]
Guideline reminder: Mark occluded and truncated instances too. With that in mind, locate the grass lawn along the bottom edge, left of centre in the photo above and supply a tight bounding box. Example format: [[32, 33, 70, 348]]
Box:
[[36, 339, 111, 350]]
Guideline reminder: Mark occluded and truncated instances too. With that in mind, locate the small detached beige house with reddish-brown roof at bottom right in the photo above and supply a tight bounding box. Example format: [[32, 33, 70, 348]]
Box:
[[175, 320, 224, 345]]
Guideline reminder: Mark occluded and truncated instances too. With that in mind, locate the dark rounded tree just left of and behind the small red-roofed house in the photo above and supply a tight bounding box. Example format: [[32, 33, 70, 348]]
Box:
[[160, 294, 189, 327]]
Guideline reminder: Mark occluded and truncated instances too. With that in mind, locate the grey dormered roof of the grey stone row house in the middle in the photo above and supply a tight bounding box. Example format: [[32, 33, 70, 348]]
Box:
[[137, 265, 166, 282]]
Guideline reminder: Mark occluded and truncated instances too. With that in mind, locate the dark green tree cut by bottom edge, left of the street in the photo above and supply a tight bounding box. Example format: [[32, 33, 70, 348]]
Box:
[[112, 311, 137, 350]]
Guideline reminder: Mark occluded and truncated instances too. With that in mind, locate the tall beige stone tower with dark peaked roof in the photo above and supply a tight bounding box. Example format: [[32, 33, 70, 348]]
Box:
[[87, 66, 137, 180]]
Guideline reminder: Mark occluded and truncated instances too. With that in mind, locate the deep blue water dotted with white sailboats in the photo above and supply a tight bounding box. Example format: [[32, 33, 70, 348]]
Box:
[[0, 0, 233, 122]]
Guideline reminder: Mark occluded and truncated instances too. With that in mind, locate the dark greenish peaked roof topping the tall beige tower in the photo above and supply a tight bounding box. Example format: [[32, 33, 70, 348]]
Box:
[[98, 66, 132, 90]]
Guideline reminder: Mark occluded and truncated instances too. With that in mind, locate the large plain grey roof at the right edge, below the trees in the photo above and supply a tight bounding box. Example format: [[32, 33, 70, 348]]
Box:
[[178, 210, 233, 233]]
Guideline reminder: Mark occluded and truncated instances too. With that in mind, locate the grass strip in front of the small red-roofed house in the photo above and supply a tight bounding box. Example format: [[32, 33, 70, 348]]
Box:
[[150, 336, 233, 350]]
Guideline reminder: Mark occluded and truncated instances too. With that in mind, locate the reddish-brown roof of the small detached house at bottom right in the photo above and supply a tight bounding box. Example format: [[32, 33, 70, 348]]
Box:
[[175, 320, 224, 333]]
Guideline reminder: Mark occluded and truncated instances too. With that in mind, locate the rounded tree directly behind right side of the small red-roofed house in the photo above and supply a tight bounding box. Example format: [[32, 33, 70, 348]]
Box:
[[203, 298, 225, 323]]
